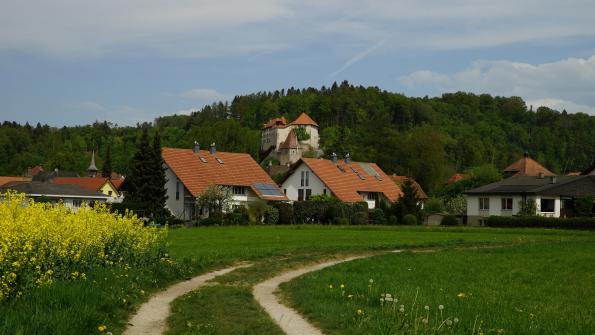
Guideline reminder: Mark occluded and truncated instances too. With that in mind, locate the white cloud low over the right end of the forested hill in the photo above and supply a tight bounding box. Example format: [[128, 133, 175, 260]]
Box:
[[399, 55, 595, 115]]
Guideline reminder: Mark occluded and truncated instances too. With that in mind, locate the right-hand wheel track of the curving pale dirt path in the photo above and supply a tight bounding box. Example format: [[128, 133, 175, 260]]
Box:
[[252, 250, 401, 335]]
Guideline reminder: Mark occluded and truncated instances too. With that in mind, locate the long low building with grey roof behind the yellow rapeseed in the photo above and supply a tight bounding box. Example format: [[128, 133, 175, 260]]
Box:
[[0, 181, 111, 209]]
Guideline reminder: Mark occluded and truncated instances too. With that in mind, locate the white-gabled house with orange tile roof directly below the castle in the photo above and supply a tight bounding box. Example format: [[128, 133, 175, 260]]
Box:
[[282, 155, 402, 209]]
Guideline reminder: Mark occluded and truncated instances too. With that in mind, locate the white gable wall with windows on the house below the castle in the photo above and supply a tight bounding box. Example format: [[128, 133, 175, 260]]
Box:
[[281, 164, 331, 201]]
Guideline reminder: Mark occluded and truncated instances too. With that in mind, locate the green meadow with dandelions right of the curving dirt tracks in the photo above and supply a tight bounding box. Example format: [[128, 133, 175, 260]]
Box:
[[282, 239, 595, 334]]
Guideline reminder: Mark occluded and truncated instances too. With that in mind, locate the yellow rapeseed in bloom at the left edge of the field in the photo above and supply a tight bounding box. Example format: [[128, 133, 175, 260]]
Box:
[[0, 192, 167, 301]]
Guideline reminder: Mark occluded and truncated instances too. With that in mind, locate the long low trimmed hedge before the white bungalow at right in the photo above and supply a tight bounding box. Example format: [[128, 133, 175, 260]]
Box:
[[487, 216, 595, 229]]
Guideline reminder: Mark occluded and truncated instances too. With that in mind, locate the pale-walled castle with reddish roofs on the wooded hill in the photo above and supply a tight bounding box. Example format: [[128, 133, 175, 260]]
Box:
[[260, 113, 320, 166]]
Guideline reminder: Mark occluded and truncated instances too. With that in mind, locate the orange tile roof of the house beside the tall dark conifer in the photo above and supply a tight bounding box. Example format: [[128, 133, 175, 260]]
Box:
[[161, 148, 287, 200]]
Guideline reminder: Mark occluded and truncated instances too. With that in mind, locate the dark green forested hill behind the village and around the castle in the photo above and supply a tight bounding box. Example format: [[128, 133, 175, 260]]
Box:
[[0, 82, 595, 194]]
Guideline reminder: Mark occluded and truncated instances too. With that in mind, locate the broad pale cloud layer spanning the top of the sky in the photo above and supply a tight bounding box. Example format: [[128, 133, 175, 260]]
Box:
[[0, 0, 595, 57]]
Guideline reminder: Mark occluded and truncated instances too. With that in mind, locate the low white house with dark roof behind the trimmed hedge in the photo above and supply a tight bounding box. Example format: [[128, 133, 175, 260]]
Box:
[[465, 174, 595, 225]]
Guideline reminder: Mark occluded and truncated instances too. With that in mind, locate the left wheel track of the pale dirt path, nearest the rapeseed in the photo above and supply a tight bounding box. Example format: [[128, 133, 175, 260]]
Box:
[[124, 264, 251, 335]]
